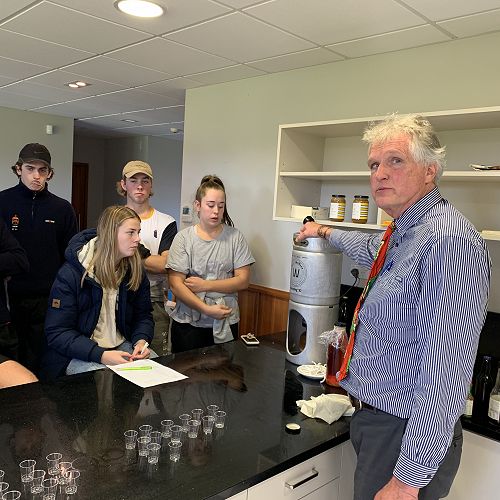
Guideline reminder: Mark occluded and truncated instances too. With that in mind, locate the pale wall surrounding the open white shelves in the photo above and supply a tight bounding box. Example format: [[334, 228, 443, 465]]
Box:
[[181, 33, 500, 296]]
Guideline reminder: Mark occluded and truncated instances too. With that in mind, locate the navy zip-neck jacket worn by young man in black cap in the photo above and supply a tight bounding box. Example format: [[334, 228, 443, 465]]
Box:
[[0, 181, 78, 298]]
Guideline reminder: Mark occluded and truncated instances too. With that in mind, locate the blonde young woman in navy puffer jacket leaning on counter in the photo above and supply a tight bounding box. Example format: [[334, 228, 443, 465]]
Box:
[[42, 206, 153, 378]]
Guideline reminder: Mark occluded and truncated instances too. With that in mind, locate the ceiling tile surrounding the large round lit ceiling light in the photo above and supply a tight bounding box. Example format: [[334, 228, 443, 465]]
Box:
[[53, 0, 230, 35]]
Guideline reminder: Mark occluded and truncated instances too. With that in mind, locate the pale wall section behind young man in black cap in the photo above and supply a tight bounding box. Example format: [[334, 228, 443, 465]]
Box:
[[0, 107, 73, 201]]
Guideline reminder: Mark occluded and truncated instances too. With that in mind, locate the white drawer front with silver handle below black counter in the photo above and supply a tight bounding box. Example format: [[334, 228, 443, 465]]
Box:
[[247, 446, 342, 500]]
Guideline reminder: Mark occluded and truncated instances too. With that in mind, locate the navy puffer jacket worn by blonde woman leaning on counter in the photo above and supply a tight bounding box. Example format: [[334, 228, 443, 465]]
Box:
[[41, 229, 154, 379]]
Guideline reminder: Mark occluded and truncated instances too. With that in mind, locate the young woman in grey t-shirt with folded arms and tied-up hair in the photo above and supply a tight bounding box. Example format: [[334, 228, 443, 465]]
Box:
[[167, 175, 255, 352]]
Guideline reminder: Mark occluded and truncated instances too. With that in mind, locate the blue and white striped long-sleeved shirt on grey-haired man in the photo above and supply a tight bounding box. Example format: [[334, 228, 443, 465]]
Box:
[[329, 188, 490, 488]]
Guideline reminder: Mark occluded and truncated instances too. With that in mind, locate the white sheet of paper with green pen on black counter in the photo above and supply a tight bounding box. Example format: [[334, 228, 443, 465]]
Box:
[[106, 359, 188, 387]]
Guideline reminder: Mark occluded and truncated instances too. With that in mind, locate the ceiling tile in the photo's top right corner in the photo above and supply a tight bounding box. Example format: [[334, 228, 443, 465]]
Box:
[[404, 0, 500, 21]]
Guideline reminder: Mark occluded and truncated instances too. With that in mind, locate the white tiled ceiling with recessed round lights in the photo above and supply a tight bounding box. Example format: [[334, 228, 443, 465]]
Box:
[[0, 0, 500, 139]]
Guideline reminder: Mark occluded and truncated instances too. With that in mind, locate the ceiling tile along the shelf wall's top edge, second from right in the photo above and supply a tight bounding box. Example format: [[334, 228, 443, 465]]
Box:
[[328, 25, 450, 57]]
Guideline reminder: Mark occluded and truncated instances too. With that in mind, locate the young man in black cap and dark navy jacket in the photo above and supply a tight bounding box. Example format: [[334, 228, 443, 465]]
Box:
[[0, 143, 77, 373]]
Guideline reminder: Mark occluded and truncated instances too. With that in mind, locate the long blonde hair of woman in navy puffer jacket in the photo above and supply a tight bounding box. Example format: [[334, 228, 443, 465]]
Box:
[[84, 205, 143, 291]]
